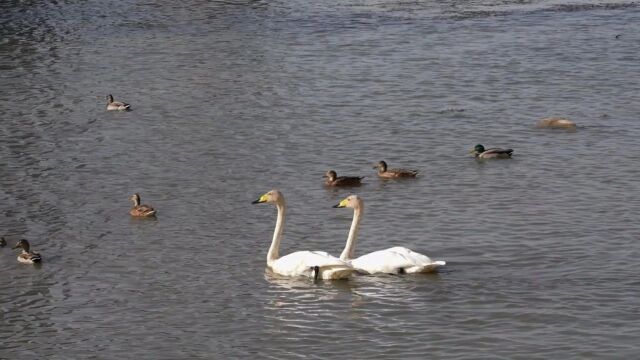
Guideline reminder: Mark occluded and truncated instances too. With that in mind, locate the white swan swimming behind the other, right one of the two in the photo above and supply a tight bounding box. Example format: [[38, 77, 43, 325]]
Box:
[[334, 195, 446, 274]]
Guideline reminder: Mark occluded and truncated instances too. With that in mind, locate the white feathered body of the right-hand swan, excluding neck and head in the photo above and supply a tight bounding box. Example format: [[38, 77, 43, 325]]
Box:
[[349, 246, 446, 274]]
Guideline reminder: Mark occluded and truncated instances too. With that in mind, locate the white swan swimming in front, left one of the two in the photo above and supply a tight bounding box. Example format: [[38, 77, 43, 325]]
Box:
[[253, 190, 355, 280]]
